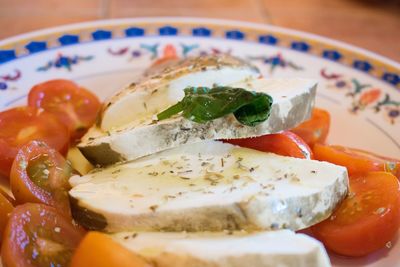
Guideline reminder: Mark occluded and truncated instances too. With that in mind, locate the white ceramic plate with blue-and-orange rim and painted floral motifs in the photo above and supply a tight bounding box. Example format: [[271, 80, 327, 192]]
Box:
[[0, 18, 400, 267]]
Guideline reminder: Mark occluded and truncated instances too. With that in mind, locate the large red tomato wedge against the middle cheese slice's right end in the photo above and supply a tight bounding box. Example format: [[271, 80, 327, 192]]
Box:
[[311, 172, 400, 256]]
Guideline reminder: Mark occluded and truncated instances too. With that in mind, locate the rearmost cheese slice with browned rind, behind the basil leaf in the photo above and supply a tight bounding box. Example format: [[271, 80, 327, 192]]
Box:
[[100, 55, 260, 132]]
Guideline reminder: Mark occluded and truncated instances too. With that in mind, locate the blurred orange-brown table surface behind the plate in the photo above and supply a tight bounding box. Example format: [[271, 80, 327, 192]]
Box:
[[0, 0, 400, 61]]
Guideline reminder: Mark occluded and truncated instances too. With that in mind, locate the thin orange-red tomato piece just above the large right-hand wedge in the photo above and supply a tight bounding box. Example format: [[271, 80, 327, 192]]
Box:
[[313, 144, 400, 178]]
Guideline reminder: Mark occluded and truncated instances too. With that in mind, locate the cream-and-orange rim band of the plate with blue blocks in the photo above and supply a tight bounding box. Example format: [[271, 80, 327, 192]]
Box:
[[0, 17, 400, 91]]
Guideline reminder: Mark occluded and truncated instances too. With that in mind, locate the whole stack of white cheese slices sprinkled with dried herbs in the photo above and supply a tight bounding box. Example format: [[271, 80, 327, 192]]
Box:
[[70, 56, 348, 267]]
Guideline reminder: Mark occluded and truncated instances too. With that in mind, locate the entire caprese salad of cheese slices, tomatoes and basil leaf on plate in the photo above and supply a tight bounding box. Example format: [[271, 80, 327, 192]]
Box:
[[0, 54, 400, 267]]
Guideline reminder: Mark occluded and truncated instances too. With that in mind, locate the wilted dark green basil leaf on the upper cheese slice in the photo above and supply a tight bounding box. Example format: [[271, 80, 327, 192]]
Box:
[[157, 87, 273, 126]]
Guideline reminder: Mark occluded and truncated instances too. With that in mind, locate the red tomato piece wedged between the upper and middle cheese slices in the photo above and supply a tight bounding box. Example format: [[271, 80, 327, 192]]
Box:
[[223, 131, 313, 159]]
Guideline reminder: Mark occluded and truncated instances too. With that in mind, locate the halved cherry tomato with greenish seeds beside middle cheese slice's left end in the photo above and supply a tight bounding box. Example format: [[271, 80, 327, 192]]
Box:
[[10, 141, 73, 214]]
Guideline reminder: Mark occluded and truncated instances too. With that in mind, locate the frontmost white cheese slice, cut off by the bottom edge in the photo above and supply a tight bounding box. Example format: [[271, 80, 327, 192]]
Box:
[[112, 230, 330, 267]]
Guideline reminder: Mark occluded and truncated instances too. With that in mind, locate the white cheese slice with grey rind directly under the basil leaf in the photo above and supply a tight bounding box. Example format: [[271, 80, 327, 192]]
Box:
[[78, 78, 316, 165]]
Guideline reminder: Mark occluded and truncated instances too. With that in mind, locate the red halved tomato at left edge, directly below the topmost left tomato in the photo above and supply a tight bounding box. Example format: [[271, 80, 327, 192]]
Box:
[[0, 107, 69, 177]]
